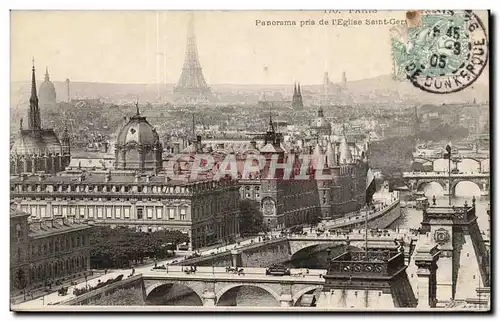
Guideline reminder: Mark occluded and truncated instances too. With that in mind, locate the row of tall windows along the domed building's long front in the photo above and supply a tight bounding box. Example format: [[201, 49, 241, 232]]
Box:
[[21, 205, 187, 221]]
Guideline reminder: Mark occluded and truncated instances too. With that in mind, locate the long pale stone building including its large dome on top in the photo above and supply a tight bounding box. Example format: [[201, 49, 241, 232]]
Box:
[[10, 109, 239, 249]]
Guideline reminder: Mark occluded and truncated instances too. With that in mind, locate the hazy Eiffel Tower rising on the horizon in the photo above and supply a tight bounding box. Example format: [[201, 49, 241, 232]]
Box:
[[174, 12, 211, 104]]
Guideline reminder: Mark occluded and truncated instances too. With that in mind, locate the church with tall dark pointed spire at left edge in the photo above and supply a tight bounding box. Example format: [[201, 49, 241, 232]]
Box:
[[10, 66, 71, 174]]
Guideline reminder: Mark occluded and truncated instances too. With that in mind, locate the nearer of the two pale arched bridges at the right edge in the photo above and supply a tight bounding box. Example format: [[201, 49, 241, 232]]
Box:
[[403, 172, 490, 195]]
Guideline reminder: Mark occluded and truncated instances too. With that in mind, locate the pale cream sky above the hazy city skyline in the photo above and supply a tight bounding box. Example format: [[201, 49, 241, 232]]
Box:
[[11, 11, 490, 84]]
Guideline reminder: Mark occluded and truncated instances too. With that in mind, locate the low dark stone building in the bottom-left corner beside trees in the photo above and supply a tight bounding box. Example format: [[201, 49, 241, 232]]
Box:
[[10, 206, 91, 290]]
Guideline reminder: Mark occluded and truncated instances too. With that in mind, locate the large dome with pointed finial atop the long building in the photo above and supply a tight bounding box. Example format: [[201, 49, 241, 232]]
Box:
[[115, 105, 163, 172]]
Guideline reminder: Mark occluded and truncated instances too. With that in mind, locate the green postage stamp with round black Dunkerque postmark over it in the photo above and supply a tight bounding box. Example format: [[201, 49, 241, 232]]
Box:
[[391, 10, 488, 94]]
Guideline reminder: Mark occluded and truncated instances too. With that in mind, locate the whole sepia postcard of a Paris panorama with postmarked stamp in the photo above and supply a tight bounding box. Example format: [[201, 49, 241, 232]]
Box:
[[10, 10, 491, 312]]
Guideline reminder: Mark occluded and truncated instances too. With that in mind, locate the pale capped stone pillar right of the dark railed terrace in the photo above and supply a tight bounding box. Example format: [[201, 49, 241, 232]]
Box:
[[415, 243, 441, 309]]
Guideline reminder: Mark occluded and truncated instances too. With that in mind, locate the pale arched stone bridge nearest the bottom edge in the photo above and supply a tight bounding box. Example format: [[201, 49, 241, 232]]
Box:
[[142, 266, 326, 307]]
